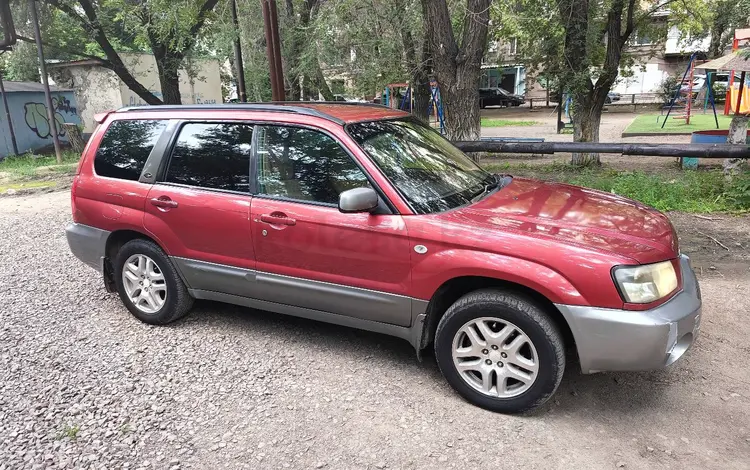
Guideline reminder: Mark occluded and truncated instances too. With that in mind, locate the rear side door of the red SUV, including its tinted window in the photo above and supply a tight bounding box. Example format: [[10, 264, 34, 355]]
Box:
[[144, 122, 255, 295]]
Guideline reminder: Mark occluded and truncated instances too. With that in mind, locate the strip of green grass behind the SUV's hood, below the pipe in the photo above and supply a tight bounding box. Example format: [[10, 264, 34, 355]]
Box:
[[485, 162, 750, 212]]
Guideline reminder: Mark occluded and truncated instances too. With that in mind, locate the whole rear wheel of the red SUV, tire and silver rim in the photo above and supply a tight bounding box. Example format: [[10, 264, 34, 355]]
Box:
[[115, 239, 193, 325]]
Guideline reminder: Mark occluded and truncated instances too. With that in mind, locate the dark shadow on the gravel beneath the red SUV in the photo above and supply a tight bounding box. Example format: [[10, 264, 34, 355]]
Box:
[[171, 301, 679, 418]]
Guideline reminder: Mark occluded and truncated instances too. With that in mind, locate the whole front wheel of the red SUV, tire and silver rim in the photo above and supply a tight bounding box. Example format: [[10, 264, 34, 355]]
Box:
[[435, 289, 565, 413]]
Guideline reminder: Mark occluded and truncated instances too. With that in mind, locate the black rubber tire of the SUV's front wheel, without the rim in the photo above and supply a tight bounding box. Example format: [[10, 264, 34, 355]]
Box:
[[435, 289, 565, 413]]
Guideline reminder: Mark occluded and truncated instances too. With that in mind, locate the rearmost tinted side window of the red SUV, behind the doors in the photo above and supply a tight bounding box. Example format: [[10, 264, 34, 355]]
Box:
[[94, 120, 167, 181]]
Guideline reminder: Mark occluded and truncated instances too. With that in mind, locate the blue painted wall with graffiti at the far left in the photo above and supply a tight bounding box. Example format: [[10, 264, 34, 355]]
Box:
[[0, 91, 81, 159]]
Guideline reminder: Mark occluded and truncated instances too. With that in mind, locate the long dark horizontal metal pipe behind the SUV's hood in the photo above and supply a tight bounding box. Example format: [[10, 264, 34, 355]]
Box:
[[454, 141, 750, 158]]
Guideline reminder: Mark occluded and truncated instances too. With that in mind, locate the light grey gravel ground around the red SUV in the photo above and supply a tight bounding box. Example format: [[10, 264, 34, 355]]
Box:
[[0, 192, 750, 470]]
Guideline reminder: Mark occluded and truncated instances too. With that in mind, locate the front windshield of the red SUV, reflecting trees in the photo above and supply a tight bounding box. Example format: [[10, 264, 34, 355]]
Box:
[[347, 120, 498, 214]]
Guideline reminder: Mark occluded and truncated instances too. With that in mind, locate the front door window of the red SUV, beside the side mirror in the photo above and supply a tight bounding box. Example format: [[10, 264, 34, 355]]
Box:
[[258, 126, 369, 204]]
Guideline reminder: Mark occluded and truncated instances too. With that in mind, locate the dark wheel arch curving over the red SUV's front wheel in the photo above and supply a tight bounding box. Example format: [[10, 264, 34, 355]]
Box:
[[419, 276, 575, 351]]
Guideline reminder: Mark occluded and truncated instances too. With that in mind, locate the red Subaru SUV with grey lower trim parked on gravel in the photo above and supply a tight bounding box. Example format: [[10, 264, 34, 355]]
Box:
[[67, 103, 701, 412]]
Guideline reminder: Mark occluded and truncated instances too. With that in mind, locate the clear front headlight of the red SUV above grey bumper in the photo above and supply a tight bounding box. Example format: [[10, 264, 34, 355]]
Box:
[[614, 261, 677, 304]]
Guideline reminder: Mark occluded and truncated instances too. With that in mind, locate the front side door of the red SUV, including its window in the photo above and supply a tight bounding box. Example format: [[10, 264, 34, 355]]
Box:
[[251, 126, 411, 326]]
